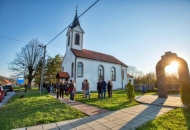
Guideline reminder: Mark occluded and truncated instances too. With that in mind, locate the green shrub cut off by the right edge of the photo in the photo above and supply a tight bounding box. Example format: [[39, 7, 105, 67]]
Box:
[[180, 81, 190, 110]]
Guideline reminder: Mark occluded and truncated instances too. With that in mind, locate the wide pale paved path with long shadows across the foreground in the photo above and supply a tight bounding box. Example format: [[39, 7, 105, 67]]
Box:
[[13, 104, 173, 130]]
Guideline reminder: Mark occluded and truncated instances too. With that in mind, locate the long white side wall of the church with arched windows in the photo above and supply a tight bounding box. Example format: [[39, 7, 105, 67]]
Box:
[[76, 57, 127, 91]]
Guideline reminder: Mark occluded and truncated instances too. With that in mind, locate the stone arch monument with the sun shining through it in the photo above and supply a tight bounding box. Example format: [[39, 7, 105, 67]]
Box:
[[156, 51, 190, 98]]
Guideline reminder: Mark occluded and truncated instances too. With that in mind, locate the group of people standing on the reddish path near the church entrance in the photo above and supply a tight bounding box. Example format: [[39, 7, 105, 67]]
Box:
[[55, 80, 76, 102]]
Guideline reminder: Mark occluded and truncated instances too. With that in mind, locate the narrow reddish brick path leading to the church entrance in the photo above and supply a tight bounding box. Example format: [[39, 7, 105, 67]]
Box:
[[51, 93, 109, 116]]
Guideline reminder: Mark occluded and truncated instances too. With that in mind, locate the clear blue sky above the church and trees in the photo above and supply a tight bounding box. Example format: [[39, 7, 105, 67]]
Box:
[[0, 0, 190, 76]]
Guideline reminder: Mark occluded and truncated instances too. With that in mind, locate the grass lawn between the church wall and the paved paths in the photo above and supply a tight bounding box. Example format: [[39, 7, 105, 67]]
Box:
[[75, 90, 155, 111]]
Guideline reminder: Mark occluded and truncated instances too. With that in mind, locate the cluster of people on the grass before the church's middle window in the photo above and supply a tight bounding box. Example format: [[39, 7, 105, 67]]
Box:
[[97, 79, 113, 99]]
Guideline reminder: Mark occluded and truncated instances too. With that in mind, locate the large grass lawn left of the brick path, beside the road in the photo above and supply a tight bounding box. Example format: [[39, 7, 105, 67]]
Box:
[[0, 90, 85, 130]]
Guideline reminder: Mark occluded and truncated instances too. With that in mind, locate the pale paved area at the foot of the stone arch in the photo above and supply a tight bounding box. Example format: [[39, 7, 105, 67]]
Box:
[[135, 95, 183, 108]]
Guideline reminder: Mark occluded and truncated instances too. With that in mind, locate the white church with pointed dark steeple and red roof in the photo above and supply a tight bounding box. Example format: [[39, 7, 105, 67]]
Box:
[[58, 13, 128, 91]]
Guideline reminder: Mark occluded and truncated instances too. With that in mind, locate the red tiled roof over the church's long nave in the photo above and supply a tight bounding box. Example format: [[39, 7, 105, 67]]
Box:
[[71, 49, 127, 67]]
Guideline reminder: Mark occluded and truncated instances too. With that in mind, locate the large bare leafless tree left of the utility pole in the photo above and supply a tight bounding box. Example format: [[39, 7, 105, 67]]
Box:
[[9, 39, 43, 88]]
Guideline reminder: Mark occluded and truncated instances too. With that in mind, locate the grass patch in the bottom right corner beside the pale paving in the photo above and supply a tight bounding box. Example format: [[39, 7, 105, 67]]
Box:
[[137, 108, 190, 130]]
